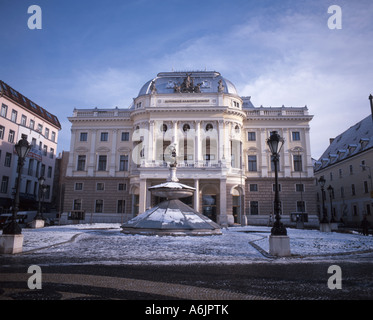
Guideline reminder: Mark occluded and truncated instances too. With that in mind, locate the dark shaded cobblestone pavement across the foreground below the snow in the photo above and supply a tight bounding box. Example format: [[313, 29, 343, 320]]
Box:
[[0, 229, 373, 301]]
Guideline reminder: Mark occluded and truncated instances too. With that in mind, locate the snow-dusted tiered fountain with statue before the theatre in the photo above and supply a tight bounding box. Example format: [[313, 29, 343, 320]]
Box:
[[121, 147, 222, 236]]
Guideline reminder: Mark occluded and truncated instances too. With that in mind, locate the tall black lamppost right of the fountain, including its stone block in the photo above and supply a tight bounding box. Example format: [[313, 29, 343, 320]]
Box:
[[267, 131, 290, 257]]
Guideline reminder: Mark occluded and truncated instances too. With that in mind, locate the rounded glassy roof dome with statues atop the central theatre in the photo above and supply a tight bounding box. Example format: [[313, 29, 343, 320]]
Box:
[[138, 71, 238, 96]]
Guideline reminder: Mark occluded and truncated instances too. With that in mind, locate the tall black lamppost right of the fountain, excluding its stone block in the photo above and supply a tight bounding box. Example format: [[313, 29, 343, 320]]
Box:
[[267, 131, 287, 236]]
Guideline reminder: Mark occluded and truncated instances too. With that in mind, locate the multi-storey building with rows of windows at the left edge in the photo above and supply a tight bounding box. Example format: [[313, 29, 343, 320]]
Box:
[[0, 81, 61, 212]]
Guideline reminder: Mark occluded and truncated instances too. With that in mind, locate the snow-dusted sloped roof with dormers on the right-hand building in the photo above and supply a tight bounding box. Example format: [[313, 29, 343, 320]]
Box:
[[315, 115, 373, 171]]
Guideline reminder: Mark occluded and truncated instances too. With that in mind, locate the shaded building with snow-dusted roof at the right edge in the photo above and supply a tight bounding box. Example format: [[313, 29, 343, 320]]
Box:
[[315, 115, 373, 227]]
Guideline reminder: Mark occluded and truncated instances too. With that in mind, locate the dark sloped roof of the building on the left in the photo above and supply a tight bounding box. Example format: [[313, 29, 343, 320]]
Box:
[[0, 80, 61, 129]]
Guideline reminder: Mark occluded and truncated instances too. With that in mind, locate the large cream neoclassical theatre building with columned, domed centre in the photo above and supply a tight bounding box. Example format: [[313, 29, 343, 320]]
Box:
[[61, 71, 317, 225]]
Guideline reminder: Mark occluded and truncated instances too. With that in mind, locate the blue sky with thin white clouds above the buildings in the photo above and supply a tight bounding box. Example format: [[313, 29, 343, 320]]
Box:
[[0, 0, 373, 158]]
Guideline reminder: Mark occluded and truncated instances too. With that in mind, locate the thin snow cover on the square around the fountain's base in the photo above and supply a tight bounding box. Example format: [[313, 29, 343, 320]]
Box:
[[18, 224, 373, 264]]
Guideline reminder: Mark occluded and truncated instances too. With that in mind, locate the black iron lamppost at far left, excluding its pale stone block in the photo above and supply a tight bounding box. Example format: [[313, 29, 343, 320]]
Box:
[[3, 134, 31, 235]]
